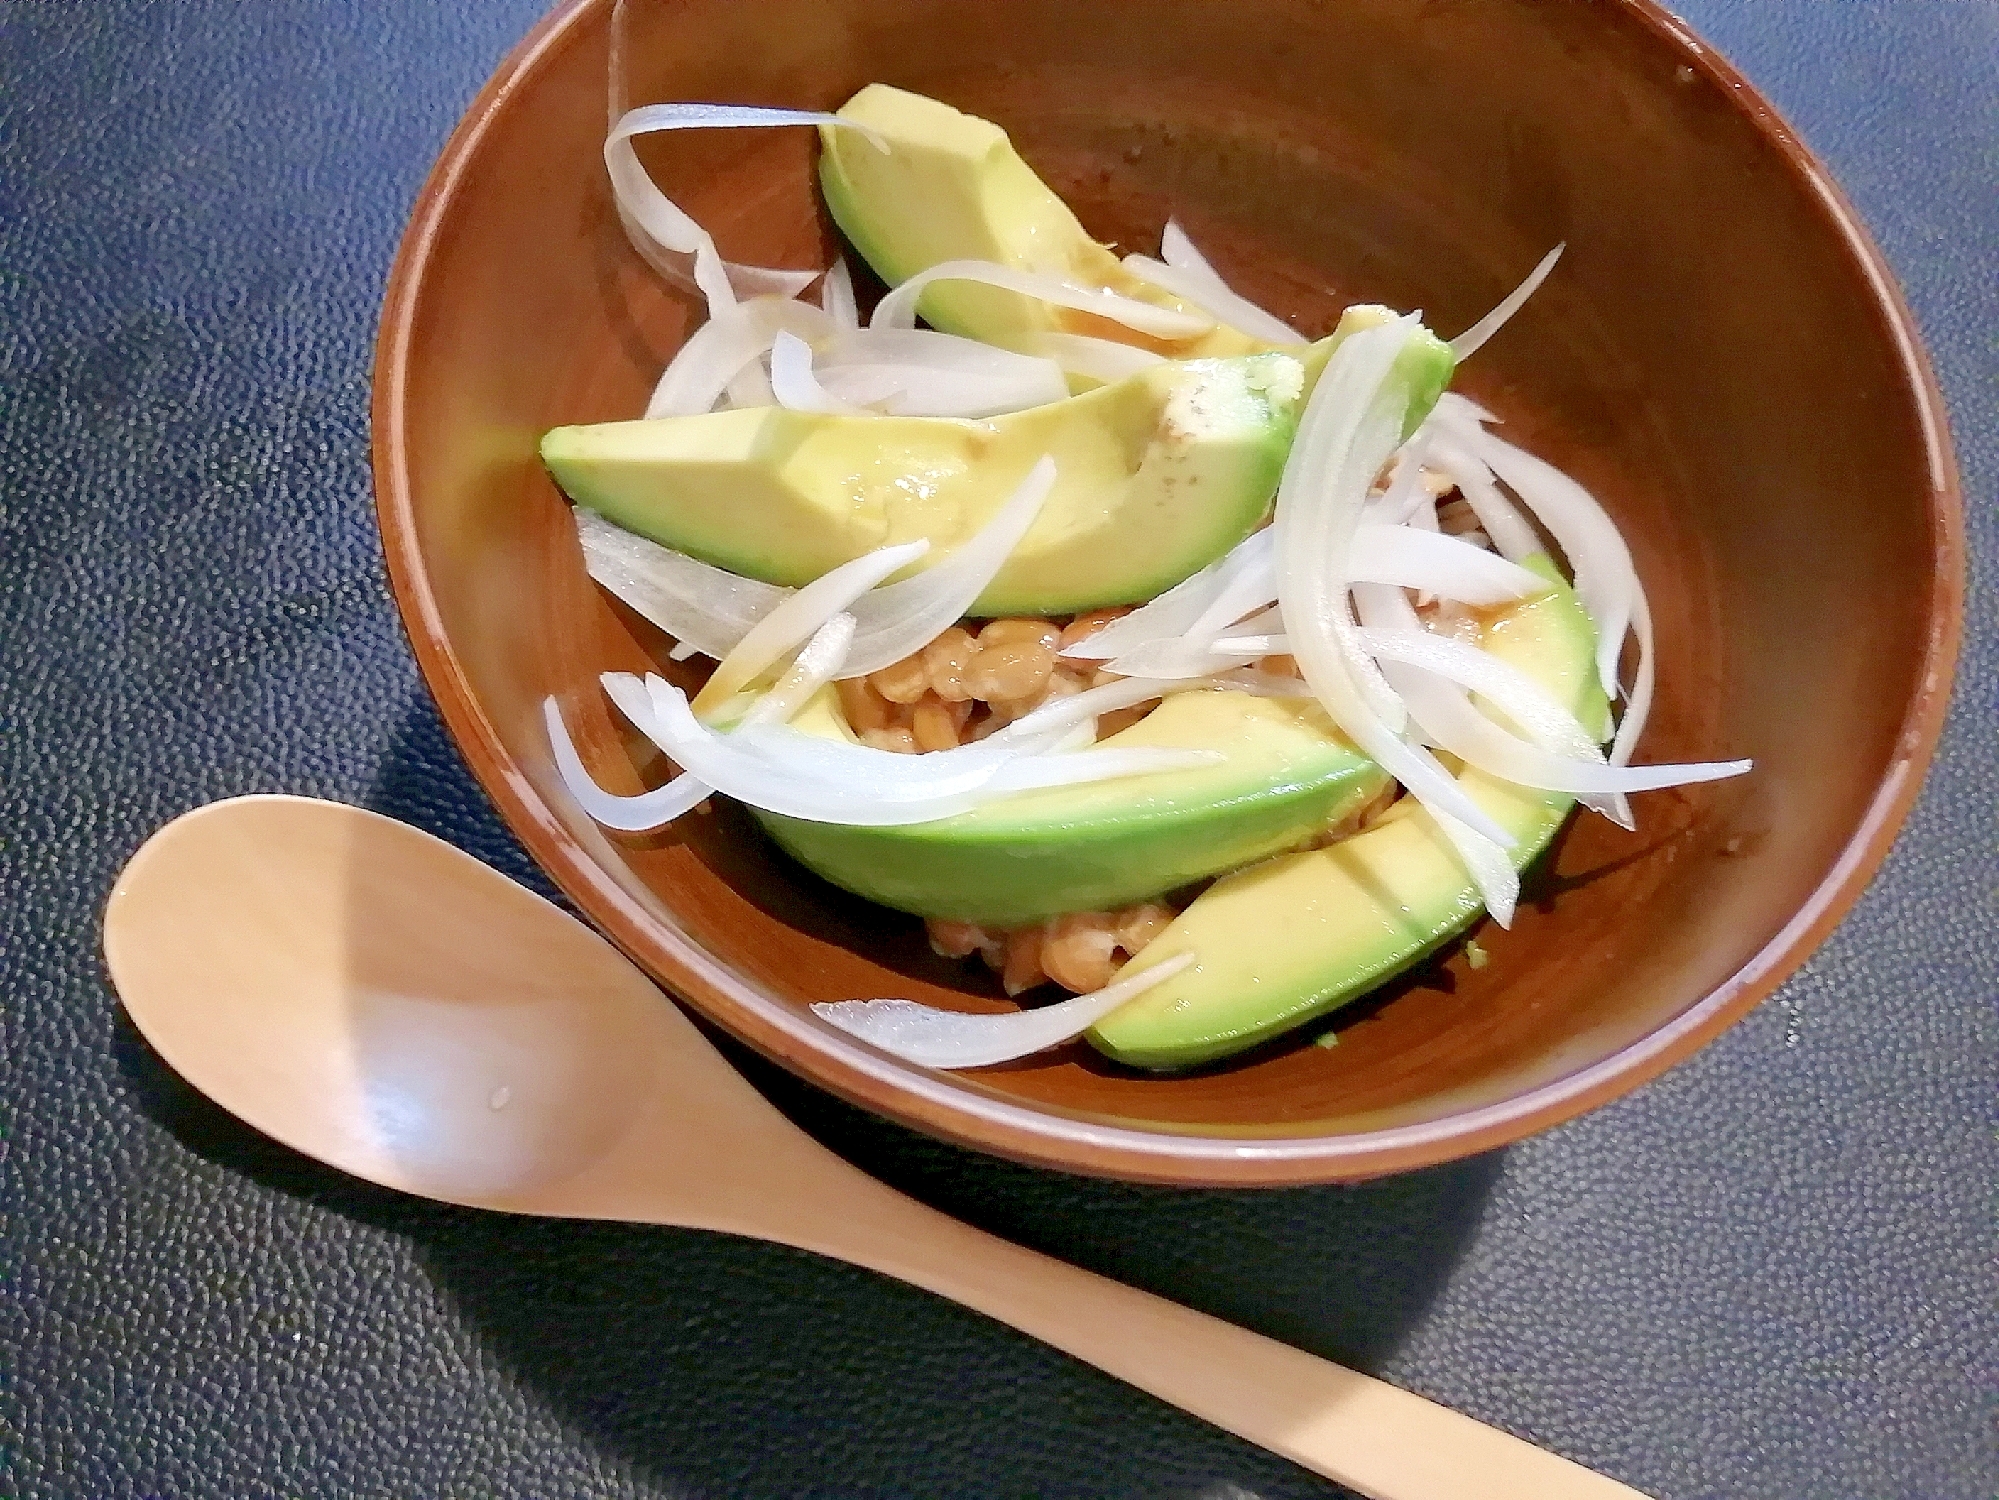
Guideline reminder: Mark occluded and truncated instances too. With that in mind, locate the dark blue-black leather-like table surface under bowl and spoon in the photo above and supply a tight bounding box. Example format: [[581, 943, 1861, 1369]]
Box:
[[0, 0, 1999, 1500]]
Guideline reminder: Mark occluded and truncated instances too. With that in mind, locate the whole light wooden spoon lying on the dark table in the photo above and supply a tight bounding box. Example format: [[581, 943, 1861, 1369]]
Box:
[[104, 796, 1637, 1500]]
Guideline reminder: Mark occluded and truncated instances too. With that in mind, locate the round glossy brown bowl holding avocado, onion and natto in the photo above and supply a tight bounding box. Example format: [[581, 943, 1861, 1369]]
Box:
[[374, 0, 1963, 1184]]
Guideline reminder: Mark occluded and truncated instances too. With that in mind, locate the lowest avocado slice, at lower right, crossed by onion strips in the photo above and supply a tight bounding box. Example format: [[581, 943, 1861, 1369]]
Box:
[[1089, 558, 1609, 1070]]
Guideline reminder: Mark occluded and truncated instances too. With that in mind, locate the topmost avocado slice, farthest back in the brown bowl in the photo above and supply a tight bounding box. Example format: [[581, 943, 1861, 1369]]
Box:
[[820, 84, 1271, 360]]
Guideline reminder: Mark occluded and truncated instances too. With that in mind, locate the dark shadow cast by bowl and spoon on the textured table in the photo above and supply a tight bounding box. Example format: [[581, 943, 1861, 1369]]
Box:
[[118, 700, 1499, 1500]]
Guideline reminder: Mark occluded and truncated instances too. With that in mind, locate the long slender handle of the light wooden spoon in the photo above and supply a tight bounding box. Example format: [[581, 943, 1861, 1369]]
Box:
[[758, 1162, 1645, 1500]]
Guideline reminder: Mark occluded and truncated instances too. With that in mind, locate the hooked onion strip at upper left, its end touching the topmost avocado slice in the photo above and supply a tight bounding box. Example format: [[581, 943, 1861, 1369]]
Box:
[[604, 104, 888, 314]]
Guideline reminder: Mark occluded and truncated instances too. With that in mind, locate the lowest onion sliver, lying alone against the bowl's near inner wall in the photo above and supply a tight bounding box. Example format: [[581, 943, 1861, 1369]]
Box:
[[812, 954, 1195, 1068]]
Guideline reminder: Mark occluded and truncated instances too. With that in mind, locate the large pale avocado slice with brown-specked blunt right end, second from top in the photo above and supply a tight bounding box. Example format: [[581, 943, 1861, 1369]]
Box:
[[542, 352, 1303, 616]]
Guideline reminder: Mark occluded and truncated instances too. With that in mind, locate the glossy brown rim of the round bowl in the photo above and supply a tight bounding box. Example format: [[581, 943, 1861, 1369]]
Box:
[[370, 0, 1965, 1186]]
